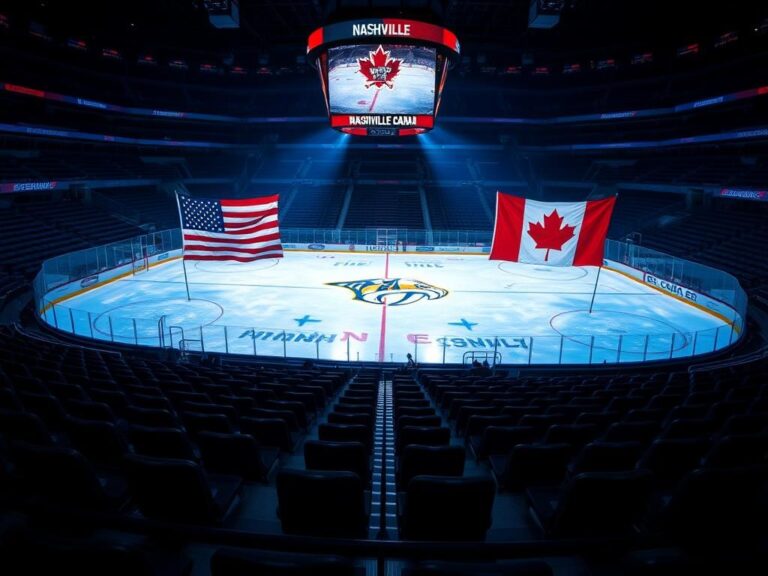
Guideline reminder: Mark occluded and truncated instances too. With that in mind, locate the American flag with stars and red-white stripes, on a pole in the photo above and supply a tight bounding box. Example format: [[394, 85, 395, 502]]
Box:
[[177, 194, 283, 262]]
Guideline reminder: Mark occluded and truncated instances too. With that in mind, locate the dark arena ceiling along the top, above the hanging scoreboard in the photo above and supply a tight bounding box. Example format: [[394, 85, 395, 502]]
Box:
[[6, 0, 768, 52]]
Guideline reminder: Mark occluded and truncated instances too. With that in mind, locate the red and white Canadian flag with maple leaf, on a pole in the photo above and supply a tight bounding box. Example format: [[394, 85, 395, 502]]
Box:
[[490, 192, 616, 266]]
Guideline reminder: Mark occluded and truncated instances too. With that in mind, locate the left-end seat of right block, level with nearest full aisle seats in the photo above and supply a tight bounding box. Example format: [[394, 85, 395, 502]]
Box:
[[527, 470, 653, 537]]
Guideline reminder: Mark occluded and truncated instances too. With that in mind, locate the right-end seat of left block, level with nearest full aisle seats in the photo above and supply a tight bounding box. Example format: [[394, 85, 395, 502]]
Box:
[[125, 454, 242, 524]]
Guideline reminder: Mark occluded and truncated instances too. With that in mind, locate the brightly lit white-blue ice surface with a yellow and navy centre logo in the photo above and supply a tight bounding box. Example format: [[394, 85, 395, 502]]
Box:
[[43, 251, 738, 364]]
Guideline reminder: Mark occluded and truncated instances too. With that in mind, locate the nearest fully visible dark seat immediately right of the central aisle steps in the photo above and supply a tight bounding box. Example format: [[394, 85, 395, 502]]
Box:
[[400, 476, 496, 541]]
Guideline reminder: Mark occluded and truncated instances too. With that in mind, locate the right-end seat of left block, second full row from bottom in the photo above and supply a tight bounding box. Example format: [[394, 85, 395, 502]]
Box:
[[197, 432, 280, 482]]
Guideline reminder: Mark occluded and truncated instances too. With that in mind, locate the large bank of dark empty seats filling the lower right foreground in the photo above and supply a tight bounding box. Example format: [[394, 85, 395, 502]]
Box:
[[422, 366, 768, 543]]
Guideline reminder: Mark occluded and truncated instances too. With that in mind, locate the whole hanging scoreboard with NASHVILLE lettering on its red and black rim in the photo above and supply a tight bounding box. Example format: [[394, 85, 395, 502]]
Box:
[[307, 18, 460, 136]]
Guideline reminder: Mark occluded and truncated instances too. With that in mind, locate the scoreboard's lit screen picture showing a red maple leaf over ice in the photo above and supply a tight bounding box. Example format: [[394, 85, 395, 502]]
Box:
[[328, 44, 437, 116]]
